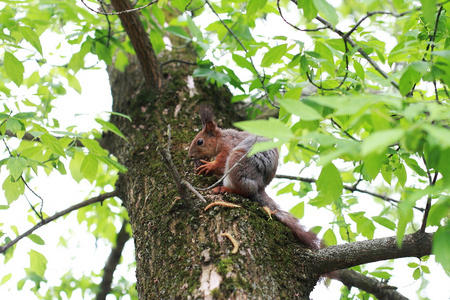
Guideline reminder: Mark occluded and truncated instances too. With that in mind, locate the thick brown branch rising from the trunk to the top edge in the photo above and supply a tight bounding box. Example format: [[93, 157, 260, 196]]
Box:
[[111, 0, 162, 90]]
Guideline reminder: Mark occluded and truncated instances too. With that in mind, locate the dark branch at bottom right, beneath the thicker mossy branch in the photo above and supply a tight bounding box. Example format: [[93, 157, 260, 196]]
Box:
[[335, 270, 408, 300]]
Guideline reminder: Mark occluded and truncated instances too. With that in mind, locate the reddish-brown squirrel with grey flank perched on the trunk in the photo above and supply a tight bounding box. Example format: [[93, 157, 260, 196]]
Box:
[[188, 106, 321, 250]]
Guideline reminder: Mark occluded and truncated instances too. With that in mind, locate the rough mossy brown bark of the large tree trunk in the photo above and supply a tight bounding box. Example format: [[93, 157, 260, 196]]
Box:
[[101, 0, 431, 299]]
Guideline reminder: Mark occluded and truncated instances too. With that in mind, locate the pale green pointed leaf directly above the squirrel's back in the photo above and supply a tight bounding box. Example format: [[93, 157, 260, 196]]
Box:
[[234, 118, 294, 141]]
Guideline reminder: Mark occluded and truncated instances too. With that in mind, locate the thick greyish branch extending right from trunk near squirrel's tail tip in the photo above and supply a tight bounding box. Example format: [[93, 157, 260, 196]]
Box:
[[316, 232, 433, 274]]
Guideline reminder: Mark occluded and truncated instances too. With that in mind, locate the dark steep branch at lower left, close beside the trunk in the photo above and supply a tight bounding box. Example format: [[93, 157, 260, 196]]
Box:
[[96, 220, 130, 300]]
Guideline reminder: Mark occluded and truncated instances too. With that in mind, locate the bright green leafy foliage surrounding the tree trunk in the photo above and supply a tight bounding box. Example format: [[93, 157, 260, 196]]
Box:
[[0, 0, 450, 298]]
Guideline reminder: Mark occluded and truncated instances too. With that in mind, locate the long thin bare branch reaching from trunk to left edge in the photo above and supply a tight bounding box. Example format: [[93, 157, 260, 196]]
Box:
[[0, 190, 118, 253]]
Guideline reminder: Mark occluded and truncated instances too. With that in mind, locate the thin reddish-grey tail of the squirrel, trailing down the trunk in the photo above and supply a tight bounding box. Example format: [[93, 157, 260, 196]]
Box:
[[252, 191, 321, 250]]
